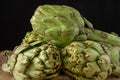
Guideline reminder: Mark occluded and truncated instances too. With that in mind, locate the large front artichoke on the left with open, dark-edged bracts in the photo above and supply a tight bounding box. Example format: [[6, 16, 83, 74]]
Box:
[[2, 41, 61, 80]]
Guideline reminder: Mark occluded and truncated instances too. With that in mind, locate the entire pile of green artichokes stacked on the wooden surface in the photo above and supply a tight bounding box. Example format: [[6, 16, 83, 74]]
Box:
[[2, 5, 120, 80]]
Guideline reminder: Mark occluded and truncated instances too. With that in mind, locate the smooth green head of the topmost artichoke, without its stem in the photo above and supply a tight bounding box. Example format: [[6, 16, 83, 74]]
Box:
[[30, 5, 84, 47]]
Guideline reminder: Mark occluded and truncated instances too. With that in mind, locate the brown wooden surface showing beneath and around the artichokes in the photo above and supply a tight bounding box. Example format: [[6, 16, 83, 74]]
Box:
[[0, 51, 120, 80]]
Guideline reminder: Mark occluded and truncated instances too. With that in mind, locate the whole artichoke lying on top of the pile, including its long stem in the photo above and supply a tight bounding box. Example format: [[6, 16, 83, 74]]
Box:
[[30, 5, 120, 47]]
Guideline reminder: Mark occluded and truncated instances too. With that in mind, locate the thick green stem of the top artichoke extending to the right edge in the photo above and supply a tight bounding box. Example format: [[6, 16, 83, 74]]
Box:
[[85, 28, 120, 46]]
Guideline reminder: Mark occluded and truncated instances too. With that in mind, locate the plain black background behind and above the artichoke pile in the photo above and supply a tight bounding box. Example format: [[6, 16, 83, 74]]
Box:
[[0, 0, 120, 50]]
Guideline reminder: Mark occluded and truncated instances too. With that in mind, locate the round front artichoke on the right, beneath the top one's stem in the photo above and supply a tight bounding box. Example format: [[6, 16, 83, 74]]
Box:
[[61, 40, 112, 80]]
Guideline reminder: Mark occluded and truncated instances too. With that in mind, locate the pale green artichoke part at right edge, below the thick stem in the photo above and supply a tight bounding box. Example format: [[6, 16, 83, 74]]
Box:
[[101, 43, 120, 77]]
